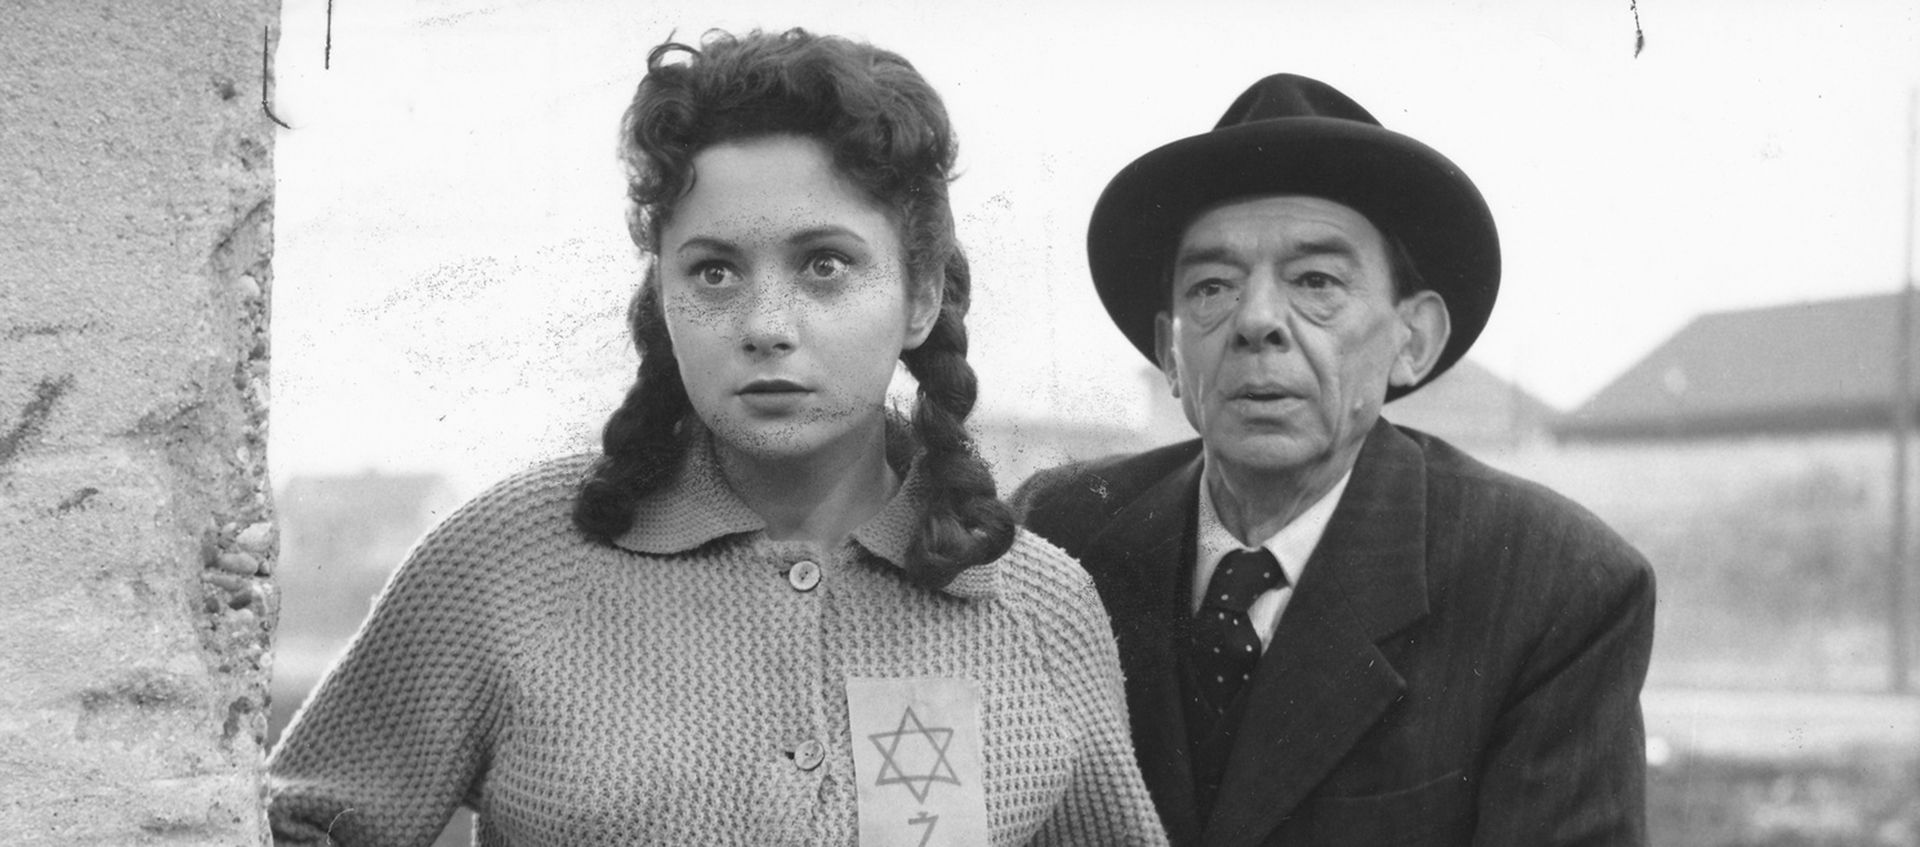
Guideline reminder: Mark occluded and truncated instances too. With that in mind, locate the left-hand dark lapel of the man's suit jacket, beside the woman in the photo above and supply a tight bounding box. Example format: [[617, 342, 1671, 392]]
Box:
[[1087, 453, 1200, 843]]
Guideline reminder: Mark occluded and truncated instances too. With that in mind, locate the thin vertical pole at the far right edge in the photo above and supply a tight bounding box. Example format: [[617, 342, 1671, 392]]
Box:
[[1887, 86, 1920, 693]]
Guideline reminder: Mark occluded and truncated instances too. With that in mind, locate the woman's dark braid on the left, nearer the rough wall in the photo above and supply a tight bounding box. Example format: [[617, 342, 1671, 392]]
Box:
[[574, 275, 693, 544]]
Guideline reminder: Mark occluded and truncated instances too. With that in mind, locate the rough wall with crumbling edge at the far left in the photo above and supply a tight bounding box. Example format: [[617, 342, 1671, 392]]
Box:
[[0, 0, 278, 845]]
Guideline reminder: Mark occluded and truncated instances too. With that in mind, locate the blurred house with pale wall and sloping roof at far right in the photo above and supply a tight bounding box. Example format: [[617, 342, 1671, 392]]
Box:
[[1523, 294, 1920, 690]]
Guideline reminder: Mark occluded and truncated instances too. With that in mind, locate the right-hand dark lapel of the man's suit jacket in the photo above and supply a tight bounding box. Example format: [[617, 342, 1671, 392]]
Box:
[[1202, 421, 1427, 847]]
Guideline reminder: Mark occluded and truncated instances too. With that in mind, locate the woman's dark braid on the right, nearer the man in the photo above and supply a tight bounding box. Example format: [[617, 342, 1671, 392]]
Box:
[[902, 252, 1014, 588]]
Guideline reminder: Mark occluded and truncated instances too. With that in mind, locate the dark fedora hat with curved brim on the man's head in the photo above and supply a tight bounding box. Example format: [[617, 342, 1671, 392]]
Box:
[[1087, 73, 1500, 399]]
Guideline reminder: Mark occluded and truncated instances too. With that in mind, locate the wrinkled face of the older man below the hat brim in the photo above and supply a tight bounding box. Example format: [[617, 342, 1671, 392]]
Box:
[[1154, 196, 1446, 486]]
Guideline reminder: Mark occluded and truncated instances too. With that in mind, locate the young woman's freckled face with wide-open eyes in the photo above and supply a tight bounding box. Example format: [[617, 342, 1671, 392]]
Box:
[[657, 136, 939, 459]]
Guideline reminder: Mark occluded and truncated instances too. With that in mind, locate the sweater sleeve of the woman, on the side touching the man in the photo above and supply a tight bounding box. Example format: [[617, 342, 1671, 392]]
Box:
[[1021, 530, 1167, 847]]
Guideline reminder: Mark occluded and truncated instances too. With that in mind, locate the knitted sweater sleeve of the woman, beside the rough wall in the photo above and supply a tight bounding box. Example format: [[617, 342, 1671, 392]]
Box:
[[269, 464, 553, 847]]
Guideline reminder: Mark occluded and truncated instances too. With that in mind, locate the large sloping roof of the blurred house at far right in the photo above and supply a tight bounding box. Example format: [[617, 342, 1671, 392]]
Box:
[[1557, 294, 1920, 440]]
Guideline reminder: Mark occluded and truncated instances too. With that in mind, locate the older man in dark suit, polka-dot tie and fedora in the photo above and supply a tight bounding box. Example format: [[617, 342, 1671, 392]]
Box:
[[1014, 75, 1653, 847]]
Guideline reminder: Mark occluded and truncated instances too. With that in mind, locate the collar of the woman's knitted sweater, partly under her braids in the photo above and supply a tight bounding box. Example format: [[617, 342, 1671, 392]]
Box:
[[614, 423, 998, 599]]
